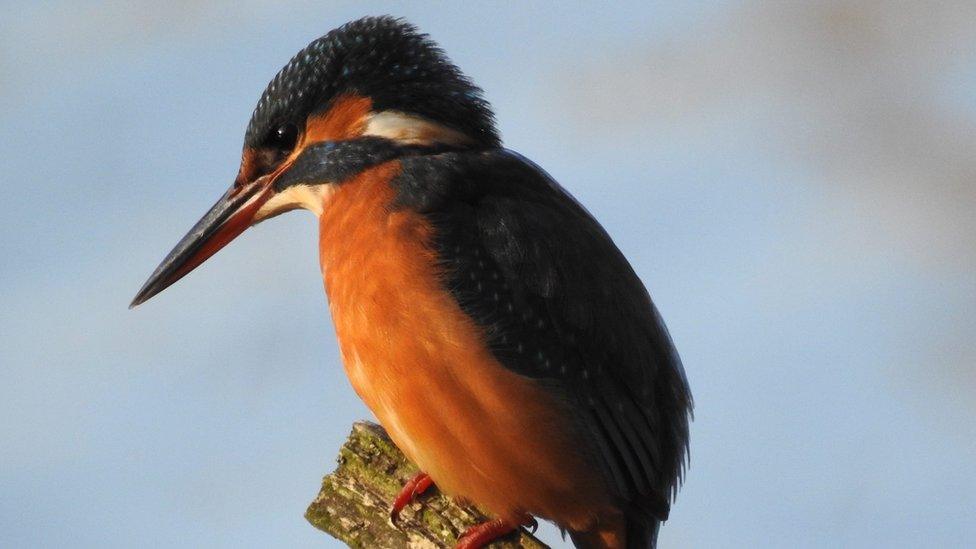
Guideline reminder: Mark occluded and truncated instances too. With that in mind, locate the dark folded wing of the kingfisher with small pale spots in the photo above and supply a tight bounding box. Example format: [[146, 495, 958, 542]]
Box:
[[398, 150, 692, 519]]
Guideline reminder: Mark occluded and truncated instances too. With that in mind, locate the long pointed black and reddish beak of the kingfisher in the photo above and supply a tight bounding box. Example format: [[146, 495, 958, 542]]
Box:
[[129, 180, 274, 309]]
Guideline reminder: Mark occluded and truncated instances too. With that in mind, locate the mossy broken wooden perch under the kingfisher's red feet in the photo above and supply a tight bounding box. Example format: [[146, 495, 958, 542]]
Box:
[[305, 422, 547, 549]]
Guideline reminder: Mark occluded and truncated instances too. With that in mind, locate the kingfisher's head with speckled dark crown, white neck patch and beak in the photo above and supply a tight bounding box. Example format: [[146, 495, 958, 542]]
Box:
[[131, 17, 499, 307]]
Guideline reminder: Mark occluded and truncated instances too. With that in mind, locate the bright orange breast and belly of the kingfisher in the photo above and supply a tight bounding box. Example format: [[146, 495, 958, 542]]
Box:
[[320, 162, 610, 530]]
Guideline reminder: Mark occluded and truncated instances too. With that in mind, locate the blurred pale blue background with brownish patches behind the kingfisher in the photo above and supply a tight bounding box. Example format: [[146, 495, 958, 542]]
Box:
[[0, 1, 976, 547]]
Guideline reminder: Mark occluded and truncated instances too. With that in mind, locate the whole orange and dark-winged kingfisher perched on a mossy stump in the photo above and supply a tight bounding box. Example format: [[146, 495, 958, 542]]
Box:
[[131, 16, 693, 549]]
